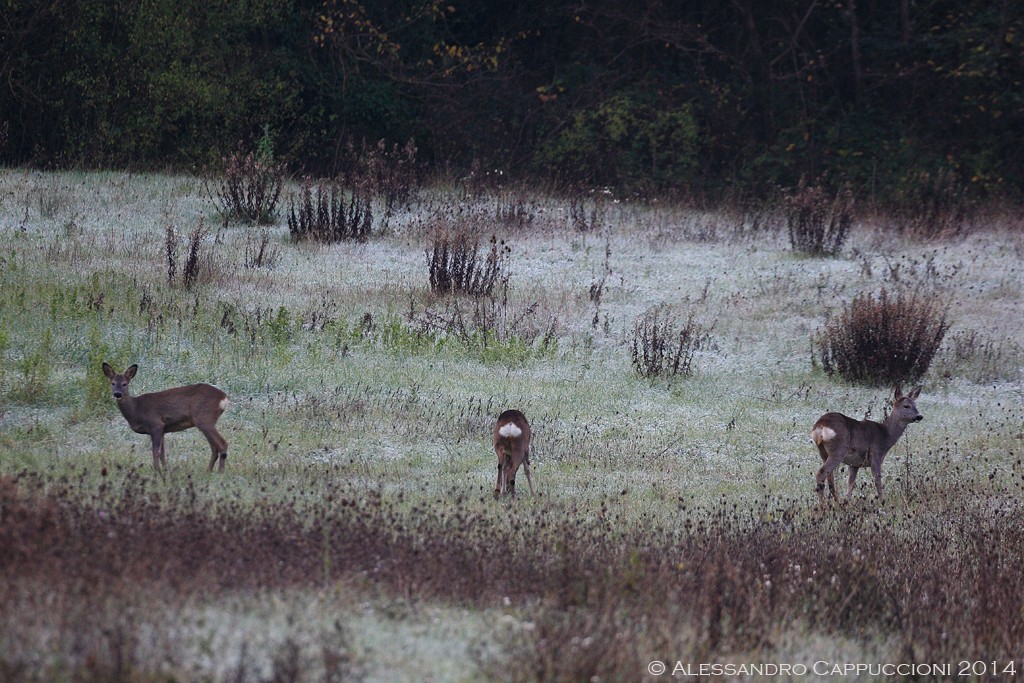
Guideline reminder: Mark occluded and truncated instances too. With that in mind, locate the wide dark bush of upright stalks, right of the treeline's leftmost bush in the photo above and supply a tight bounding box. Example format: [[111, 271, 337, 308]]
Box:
[[288, 178, 374, 242]]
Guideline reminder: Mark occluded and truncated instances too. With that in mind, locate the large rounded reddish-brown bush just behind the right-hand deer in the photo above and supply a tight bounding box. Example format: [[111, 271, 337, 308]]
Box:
[[814, 288, 949, 386]]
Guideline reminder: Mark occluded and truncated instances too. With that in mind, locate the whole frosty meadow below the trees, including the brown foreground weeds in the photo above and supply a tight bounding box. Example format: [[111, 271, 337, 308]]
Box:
[[0, 170, 1024, 681]]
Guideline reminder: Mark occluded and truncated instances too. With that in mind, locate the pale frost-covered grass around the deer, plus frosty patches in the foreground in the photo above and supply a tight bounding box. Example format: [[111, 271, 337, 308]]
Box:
[[0, 170, 1024, 680]]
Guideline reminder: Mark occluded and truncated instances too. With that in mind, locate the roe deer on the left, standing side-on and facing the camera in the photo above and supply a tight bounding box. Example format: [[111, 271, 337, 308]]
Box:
[[103, 362, 228, 472]]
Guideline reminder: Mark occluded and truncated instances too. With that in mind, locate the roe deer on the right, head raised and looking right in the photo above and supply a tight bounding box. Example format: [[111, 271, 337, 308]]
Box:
[[811, 387, 925, 504]]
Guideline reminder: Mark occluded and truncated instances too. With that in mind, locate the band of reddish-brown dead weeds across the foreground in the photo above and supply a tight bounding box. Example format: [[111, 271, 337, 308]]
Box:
[[0, 471, 1024, 683]]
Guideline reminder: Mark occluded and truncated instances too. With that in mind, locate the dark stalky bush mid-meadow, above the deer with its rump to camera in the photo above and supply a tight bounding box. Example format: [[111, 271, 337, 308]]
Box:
[[427, 230, 511, 296]]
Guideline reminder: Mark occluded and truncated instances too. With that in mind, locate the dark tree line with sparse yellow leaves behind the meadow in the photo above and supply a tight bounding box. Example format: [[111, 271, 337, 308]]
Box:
[[0, 0, 1024, 198]]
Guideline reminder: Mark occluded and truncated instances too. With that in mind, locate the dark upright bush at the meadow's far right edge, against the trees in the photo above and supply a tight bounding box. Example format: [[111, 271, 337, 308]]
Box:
[[785, 178, 853, 256]]
